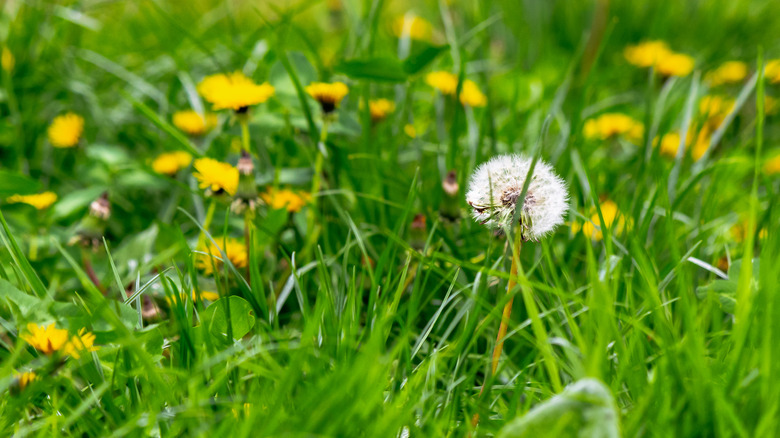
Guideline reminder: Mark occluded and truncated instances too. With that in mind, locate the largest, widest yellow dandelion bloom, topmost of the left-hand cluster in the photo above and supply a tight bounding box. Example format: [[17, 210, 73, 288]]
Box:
[[198, 71, 275, 112]]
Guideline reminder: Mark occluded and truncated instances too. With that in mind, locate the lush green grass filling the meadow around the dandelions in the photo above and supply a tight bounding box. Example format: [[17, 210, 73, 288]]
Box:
[[0, 0, 780, 437]]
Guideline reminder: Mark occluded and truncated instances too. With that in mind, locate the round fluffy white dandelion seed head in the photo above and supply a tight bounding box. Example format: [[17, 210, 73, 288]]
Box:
[[466, 155, 569, 240]]
